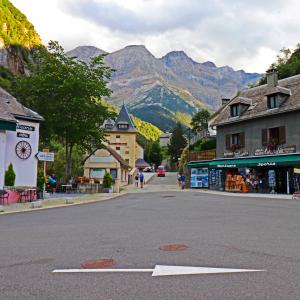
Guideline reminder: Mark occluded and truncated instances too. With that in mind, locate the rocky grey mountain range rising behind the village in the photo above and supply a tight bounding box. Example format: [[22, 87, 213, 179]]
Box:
[[66, 45, 261, 131]]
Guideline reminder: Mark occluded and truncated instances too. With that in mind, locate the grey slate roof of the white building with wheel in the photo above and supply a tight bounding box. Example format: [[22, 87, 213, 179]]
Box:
[[0, 87, 44, 123]]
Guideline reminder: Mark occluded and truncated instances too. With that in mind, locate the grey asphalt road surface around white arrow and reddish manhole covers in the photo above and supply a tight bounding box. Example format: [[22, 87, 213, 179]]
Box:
[[0, 174, 300, 300]]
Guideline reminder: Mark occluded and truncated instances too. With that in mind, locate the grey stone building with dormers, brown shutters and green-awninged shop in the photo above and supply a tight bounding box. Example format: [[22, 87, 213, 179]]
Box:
[[189, 72, 300, 194]]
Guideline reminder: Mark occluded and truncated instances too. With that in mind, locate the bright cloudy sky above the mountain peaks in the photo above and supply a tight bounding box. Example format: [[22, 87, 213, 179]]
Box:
[[11, 0, 300, 72]]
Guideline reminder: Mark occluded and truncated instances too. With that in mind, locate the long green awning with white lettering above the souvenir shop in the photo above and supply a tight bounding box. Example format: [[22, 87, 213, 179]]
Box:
[[188, 153, 300, 169]]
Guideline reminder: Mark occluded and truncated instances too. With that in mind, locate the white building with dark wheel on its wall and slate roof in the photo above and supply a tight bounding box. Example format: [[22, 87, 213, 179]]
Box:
[[0, 88, 43, 188]]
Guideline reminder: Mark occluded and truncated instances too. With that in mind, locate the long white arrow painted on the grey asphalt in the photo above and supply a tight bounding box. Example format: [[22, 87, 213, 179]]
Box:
[[53, 265, 265, 276]]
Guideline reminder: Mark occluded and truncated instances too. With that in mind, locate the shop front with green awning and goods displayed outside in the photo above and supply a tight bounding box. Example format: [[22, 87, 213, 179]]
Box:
[[188, 153, 300, 194]]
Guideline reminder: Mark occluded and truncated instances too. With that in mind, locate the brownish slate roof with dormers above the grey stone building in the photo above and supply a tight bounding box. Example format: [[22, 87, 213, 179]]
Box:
[[211, 75, 300, 126]]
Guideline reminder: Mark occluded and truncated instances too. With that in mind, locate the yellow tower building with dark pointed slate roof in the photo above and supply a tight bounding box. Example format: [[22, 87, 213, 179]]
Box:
[[103, 103, 138, 168]]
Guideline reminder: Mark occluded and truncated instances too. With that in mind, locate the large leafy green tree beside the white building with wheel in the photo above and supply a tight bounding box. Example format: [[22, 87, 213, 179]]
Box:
[[16, 42, 112, 179]]
